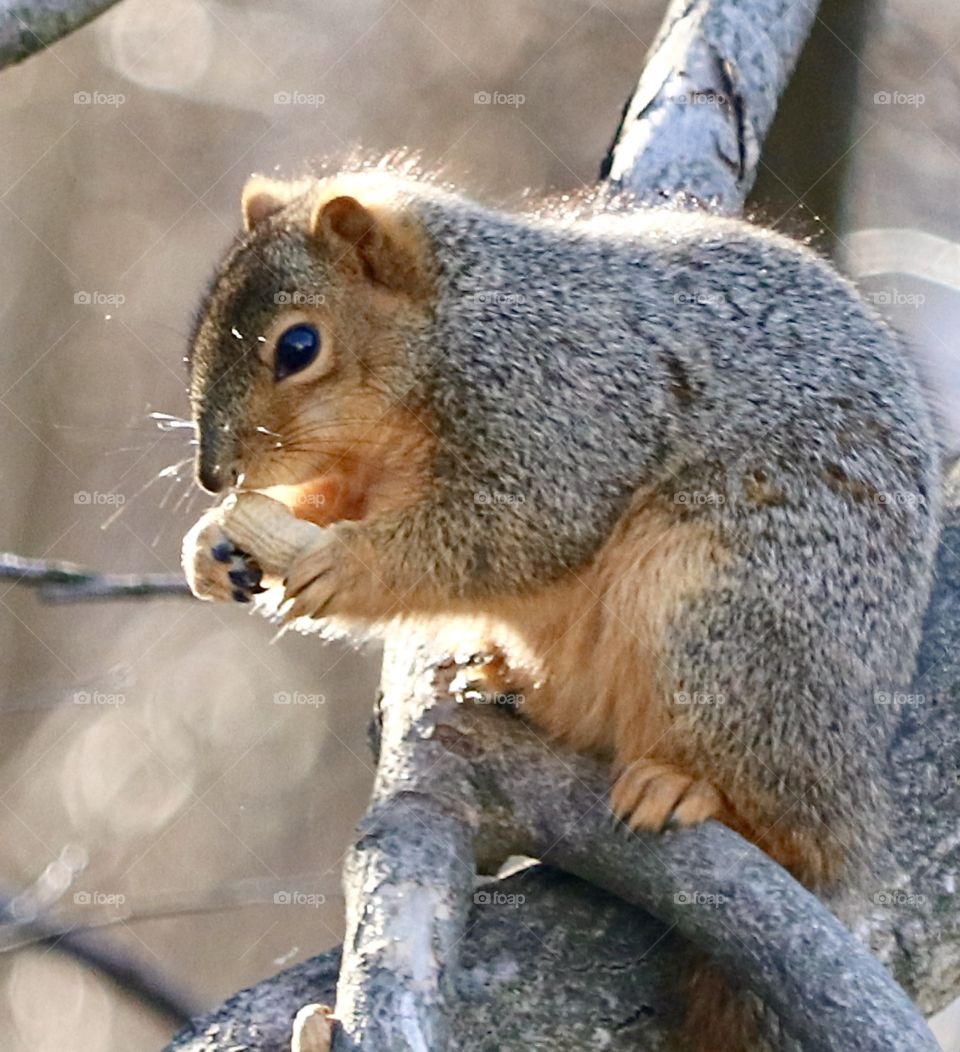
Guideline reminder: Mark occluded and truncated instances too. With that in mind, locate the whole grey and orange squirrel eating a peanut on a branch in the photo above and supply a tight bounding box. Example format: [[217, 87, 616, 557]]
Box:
[[177, 165, 940, 1049]]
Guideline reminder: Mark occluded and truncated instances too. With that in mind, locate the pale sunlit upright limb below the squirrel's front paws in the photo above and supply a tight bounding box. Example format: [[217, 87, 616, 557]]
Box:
[[336, 654, 482, 1050]]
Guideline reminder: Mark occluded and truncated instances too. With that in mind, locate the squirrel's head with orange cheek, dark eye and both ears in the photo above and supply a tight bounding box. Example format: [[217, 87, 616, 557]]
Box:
[[187, 173, 435, 522]]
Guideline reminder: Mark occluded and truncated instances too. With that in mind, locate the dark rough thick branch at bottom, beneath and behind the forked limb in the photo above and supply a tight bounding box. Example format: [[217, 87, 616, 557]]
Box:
[[168, 867, 685, 1052]]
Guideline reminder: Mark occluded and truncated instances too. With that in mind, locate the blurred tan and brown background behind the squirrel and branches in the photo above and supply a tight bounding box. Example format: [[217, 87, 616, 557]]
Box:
[[0, 0, 960, 1052]]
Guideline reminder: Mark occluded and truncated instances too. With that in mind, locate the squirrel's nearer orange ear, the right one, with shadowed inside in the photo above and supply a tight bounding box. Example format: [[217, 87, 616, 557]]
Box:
[[311, 194, 425, 297]]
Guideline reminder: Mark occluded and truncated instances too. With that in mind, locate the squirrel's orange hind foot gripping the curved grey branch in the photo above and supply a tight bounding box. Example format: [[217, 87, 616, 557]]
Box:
[[610, 758, 724, 832]]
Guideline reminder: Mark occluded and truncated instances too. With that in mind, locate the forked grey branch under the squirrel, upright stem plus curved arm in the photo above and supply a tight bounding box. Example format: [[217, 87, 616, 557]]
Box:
[[335, 641, 937, 1052]]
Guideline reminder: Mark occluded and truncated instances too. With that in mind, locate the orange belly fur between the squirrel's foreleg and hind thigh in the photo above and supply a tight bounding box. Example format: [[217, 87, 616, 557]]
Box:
[[487, 494, 729, 765]]
